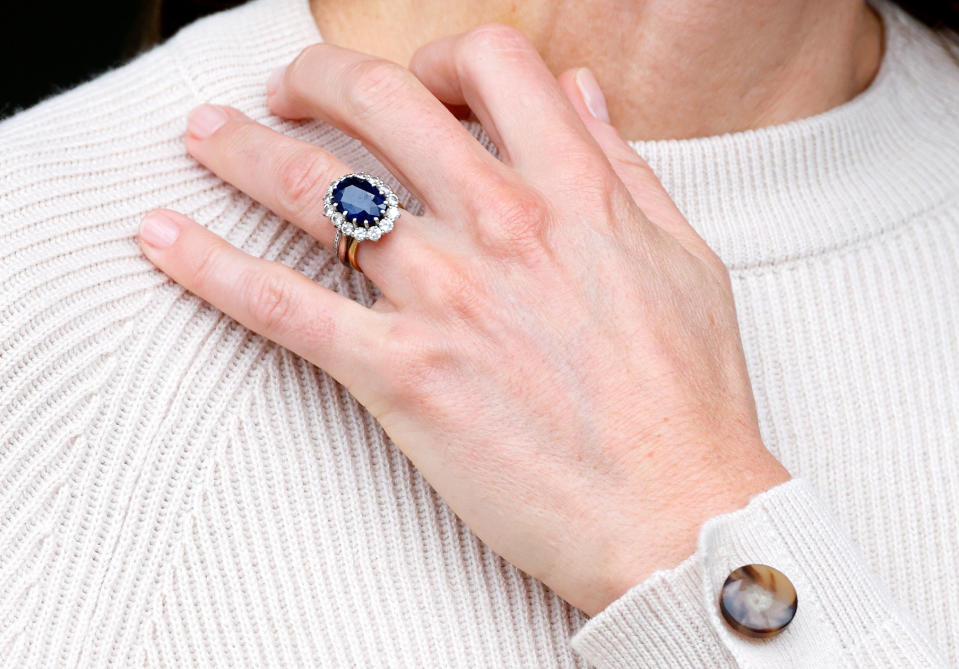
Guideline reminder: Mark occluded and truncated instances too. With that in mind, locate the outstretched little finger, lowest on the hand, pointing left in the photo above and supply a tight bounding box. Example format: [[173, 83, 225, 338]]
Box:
[[138, 209, 386, 397]]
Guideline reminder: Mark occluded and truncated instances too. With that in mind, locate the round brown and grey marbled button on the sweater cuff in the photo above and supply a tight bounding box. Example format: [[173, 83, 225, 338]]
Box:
[[719, 564, 799, 639]]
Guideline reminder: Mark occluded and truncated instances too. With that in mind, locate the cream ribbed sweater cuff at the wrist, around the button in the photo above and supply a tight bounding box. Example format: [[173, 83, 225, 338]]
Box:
[[571, 478, 945, 667]]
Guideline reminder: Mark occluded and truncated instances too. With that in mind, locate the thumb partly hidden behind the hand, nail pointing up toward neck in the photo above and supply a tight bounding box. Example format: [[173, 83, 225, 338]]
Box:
[[558, 68, 712, 264]]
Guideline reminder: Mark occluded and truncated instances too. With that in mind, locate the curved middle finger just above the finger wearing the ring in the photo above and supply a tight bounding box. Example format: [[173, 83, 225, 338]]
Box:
[[268, 44, 505, 215]]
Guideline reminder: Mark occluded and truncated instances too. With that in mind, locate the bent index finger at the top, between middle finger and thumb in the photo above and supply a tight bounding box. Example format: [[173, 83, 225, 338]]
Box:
[[410, 24, 595, 175]]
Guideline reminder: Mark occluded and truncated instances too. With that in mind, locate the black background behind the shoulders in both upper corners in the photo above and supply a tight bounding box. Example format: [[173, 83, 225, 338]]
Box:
[[0, 0, 959, 118]]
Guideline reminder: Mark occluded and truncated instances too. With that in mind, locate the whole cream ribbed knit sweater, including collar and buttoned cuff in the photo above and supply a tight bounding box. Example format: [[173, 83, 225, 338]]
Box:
[[0, 0, 959, 668]]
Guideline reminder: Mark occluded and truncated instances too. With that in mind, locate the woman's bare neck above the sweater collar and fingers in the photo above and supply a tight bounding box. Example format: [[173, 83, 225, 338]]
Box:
[[312, 0, 882, 139]]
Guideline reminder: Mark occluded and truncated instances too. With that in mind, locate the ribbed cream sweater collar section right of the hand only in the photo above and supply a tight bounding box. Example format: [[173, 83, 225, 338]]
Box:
[[630, 2, 959, 271]]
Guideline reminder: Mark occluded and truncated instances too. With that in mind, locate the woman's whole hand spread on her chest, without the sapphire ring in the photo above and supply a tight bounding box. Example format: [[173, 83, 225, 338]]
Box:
[[140, 25, 789, 614]]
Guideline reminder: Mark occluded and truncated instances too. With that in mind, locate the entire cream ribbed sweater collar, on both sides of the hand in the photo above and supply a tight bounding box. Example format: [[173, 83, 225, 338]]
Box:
[[174, 0, 959, 271]]
